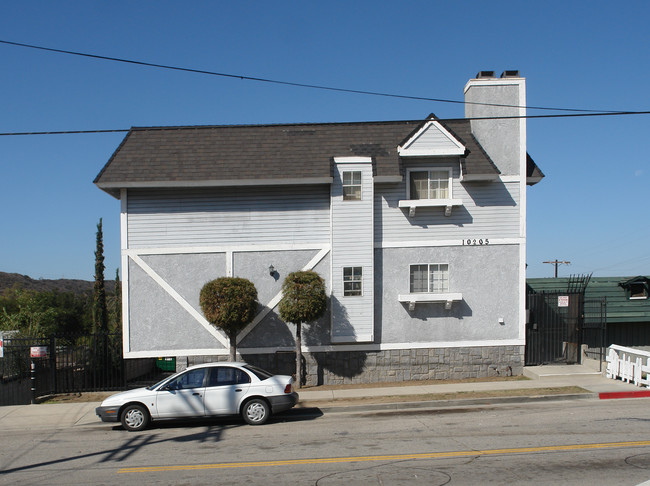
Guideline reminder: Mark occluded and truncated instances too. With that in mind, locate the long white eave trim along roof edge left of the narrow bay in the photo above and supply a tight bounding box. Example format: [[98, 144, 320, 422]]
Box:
[[97, 177, 334, 190]]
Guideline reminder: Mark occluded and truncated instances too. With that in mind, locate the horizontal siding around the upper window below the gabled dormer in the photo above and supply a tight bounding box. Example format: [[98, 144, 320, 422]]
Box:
[[374, 179, 520, 245]]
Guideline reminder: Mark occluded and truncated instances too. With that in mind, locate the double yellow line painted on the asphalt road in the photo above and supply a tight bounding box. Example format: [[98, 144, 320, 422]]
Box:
[[118, 440, 650, 473]]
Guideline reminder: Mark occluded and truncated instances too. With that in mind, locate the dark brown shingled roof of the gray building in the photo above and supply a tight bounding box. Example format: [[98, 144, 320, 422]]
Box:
[[94, 116, 520, 197]]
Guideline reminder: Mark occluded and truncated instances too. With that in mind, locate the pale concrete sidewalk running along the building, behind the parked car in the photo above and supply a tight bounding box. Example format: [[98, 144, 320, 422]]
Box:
[[0, 365, 650, 431]]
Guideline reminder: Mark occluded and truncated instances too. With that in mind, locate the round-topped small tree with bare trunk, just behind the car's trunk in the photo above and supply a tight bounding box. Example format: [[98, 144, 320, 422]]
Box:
[[278, 271, 327, 388]]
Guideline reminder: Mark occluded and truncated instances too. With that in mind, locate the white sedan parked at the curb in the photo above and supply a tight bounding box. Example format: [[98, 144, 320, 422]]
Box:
[[95, 363, 298, 431]]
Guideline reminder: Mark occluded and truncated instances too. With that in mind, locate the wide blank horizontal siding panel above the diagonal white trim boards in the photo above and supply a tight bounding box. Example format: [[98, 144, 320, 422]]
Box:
[[127, 185, 330, 249]]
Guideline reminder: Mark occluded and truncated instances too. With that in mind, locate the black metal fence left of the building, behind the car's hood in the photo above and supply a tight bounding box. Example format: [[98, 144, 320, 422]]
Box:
[[0, 333, 169, 405]]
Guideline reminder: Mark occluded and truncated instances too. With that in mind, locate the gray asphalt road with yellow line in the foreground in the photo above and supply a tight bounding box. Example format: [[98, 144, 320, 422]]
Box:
[[0, 399, 650, 486]]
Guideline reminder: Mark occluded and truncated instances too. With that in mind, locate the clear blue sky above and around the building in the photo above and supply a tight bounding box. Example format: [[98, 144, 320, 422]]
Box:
[[0, 0, 650, 280]]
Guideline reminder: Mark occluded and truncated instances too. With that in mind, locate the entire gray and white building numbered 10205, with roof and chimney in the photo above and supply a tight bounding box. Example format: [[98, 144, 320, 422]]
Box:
[[95, 71, 543, 384]]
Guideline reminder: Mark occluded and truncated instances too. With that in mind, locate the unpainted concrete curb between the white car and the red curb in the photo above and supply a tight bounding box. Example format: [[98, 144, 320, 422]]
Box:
[[292, 393, 599, 414]]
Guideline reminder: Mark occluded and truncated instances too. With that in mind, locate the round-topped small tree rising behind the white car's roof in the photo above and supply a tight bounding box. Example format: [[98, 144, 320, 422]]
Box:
[[199, 277, 257, 361]]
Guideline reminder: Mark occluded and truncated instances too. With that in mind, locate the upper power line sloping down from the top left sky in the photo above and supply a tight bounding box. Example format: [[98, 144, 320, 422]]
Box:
[[0, 40, 632, 113]]
